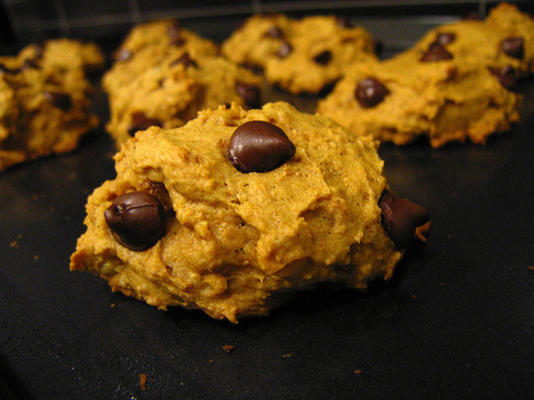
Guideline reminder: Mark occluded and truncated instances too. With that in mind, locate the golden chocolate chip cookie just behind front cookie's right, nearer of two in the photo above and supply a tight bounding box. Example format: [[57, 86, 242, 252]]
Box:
[[317, 51, 522, 147]]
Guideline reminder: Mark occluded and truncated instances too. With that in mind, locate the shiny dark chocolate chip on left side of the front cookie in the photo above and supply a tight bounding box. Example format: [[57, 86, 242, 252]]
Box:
[[104, 192, 165, 251]]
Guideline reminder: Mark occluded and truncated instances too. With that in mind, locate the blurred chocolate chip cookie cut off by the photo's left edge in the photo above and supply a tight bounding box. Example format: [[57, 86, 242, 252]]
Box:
[[0, 39, 101, 170]]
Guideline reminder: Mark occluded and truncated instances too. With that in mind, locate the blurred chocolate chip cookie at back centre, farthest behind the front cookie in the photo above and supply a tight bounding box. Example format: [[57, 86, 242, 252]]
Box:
[[222, 15, 376, 94]]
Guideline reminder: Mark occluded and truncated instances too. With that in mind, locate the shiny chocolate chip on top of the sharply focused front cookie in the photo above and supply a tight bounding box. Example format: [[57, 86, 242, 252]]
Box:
[[228, 121, 295, 173]]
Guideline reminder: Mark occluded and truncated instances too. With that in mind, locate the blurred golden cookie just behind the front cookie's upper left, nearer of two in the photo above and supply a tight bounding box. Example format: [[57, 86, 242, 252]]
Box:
[[107, 52, 261, 144]]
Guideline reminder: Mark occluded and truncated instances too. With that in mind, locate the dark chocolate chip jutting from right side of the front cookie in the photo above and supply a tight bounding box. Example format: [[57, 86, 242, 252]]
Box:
[[378, 189, 430, 249]]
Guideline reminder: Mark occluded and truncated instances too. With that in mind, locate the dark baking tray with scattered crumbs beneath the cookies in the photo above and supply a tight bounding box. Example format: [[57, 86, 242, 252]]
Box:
[[0, 14, 534, 400]]
